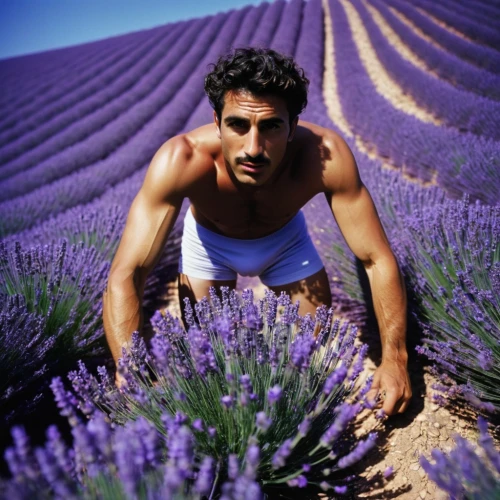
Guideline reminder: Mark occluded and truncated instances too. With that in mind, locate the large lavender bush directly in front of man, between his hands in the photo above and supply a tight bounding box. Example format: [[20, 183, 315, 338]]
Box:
[[52, 287, 376, 498]]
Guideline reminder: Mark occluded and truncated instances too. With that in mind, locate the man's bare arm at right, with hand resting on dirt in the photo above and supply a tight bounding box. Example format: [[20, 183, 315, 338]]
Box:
[[324, 136, 411, 414]]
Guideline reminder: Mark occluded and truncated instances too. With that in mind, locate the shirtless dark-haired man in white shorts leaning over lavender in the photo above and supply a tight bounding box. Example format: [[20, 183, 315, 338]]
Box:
[[103, 48, 411, 415]]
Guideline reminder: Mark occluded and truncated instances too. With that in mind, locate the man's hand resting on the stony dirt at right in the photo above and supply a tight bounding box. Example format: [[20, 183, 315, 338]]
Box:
[[366, 361, 412, 415]]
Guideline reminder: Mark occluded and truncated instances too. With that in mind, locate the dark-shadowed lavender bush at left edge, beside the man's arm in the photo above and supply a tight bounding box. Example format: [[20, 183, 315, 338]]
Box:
[[0, 239, 110, 420]]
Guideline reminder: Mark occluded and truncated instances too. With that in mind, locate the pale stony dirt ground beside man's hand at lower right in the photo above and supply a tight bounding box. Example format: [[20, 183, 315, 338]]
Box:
[[350, 359, 477, 500]]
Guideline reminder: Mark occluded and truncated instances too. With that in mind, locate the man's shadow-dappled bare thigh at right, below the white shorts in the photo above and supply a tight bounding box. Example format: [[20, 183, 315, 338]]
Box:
[[268, 268, 332, 316]]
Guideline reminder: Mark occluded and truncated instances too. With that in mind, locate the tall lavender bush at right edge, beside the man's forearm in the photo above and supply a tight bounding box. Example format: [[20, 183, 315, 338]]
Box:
[[397, 197, 500, 411]]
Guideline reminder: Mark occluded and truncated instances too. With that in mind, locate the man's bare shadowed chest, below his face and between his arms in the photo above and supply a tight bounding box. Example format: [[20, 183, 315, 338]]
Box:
[[180, 122, 331, 239]]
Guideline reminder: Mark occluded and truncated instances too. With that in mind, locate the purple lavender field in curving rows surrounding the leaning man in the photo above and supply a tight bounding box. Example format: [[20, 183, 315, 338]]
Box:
[[0, 0, 500, 498]]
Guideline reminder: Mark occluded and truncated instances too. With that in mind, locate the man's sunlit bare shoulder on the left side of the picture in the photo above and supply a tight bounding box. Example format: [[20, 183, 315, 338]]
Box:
[[143, 126, 216, 197]]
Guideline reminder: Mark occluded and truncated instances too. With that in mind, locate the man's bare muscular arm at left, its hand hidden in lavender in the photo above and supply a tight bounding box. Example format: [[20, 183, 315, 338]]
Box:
[[103, 137, 190, 362]]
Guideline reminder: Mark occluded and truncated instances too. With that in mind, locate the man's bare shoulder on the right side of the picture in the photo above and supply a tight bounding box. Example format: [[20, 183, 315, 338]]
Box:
[[299, 121, 361, 193]]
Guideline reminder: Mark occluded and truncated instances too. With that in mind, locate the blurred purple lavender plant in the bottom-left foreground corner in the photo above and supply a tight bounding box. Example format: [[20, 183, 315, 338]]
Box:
[[0, 413, 240, 500]]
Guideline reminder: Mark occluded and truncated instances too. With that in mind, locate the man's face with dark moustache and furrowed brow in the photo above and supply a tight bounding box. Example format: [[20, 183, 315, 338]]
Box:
[[214, 91, 298, 186]]
